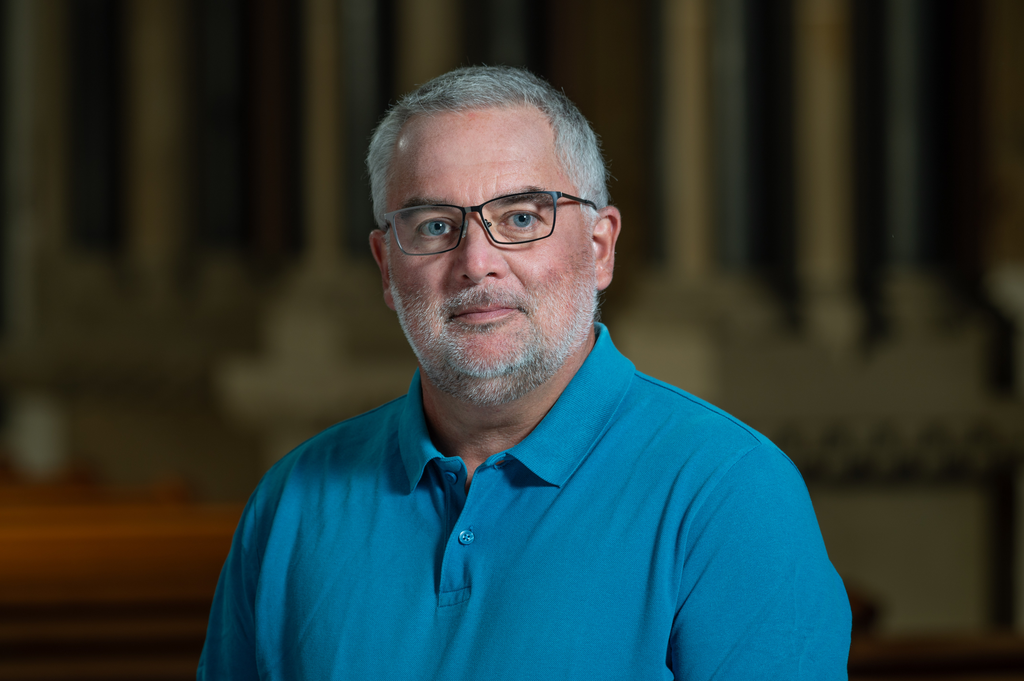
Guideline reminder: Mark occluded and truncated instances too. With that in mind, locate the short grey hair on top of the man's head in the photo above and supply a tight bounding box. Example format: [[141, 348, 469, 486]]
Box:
[[367, 67, 608, 226]]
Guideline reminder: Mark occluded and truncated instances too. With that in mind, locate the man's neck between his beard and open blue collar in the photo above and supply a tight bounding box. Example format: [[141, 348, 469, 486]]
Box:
[[420, 329, 595, 487]]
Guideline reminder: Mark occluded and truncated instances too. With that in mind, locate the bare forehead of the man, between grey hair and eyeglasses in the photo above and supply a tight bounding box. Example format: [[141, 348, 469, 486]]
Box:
[[388, 107, 575, 210]]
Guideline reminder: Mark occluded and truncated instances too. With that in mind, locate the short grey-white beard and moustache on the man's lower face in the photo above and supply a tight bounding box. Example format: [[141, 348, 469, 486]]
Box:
[[390, 268, 597, 407]]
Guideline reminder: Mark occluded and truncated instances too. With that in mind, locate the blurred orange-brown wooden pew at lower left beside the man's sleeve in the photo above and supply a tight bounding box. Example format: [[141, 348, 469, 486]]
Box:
[[0, 473, 243, 681]]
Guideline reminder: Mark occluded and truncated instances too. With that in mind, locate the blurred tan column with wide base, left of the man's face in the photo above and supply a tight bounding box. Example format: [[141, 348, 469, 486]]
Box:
[[216, 0, 409, 466]]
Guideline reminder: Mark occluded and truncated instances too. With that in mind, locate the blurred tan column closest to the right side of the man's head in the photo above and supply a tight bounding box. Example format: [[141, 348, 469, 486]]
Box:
[[662, 0, 715, 288]]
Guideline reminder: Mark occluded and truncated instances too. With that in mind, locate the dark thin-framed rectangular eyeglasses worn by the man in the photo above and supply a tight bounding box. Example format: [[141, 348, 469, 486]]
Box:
[[384, 191, 597, 255]]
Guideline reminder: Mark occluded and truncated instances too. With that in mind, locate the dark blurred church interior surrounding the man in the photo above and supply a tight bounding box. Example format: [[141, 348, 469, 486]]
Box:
[[0, 0, 1024, 679]]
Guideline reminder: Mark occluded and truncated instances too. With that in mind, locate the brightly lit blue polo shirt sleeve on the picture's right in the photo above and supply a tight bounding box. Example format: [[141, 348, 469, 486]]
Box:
[[670, 443, 850, 681]]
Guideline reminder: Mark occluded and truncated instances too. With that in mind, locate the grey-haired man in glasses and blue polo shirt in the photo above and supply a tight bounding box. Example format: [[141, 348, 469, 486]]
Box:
[[199, 68, 850, 681]]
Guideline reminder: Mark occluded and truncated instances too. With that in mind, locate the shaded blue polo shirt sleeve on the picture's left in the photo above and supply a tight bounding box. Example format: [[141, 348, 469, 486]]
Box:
[[196, 494, 259, 681]]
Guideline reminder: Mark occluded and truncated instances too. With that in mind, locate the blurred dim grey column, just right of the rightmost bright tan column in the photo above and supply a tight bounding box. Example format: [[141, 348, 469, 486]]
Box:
[[883, 0, 943, 332]]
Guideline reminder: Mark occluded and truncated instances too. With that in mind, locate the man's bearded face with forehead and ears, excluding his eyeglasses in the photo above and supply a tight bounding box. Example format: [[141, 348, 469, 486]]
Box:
[[371, 108, 618, 406]]
